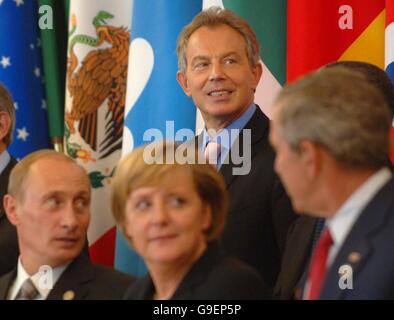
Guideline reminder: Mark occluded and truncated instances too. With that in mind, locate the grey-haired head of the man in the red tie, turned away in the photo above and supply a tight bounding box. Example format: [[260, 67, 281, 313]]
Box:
[[270, 68, 391, 213]]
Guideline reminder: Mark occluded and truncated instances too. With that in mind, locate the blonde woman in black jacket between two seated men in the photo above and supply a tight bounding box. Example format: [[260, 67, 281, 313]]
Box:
[[111, 142, 269, 300]]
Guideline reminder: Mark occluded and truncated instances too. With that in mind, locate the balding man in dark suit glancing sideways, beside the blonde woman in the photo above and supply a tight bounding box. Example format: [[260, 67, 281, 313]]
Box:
[[0, 150, 132, 300]]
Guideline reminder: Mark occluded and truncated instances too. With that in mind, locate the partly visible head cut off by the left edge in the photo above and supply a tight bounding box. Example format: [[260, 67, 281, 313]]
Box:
[[0, 84, 15, 152]]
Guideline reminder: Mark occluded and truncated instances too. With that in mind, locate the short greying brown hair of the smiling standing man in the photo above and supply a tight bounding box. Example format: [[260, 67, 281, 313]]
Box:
[[176, 7, 260, 73]]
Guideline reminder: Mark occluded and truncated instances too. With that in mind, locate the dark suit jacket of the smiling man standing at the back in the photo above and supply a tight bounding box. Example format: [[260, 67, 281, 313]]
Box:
[[198, 107, 297, 288]]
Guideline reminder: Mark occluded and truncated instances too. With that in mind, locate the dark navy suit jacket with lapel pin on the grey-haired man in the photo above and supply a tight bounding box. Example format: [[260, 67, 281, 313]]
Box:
[[320, 178, 394, 300]]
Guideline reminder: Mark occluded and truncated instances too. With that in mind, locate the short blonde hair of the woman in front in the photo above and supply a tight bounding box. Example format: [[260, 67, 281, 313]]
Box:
[[111, 142, 228, 245]]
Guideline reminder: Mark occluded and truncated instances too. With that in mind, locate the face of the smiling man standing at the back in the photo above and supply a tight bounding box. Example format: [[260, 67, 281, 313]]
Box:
[[177, 25, 262, 130]]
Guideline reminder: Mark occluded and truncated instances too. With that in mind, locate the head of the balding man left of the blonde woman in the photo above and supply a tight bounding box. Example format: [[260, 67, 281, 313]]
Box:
[[4, 150, 90, 273]]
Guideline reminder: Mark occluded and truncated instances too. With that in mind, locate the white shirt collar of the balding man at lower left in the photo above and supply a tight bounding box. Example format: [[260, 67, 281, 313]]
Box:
[[9, 257, 70, 300]]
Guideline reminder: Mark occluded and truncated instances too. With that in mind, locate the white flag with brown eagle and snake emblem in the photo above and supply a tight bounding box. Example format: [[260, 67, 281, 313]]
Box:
[[65, 0, 132, 266]]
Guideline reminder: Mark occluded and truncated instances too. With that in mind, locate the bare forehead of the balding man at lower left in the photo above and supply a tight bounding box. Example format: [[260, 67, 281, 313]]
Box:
[[24, 158, 89, 189]]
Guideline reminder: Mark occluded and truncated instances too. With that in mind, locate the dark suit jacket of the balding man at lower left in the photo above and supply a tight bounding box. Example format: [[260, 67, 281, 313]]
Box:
[[0, 253, 134, 300]]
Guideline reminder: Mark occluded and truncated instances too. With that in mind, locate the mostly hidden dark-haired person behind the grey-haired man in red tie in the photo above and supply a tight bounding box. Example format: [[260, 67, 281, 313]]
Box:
[[274, 61, 394, 299]]
